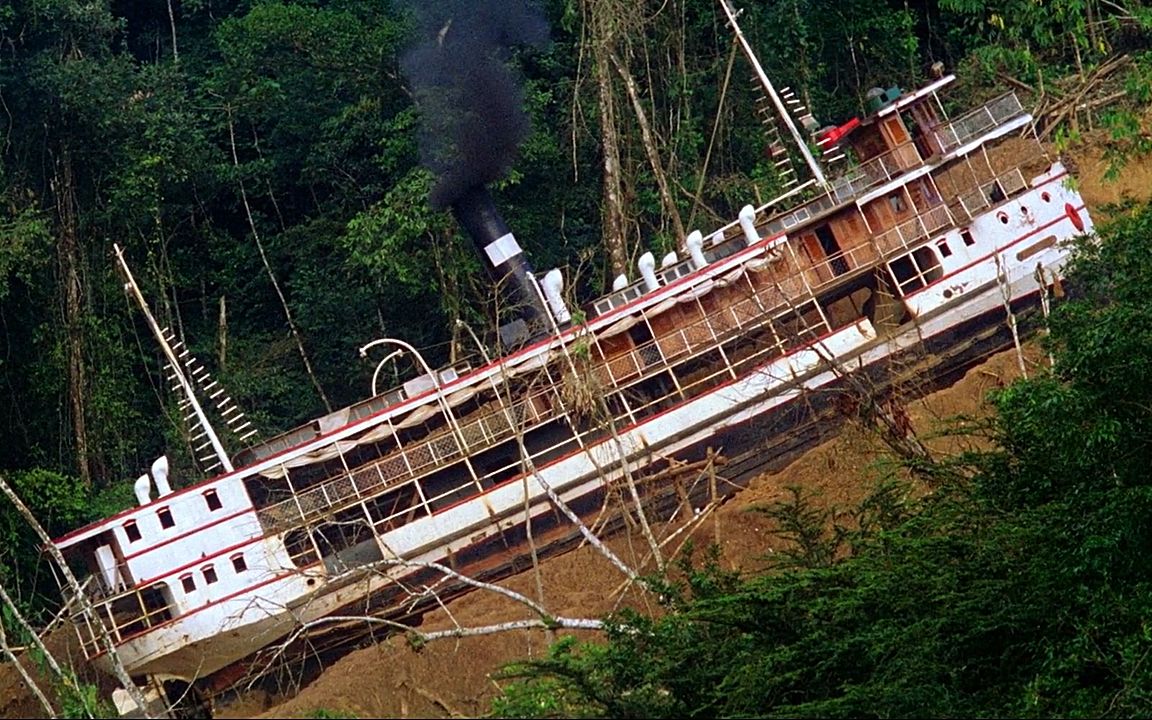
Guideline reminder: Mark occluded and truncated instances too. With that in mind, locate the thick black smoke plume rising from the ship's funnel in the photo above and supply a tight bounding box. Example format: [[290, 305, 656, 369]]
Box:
[[401, 0, 548, 209]]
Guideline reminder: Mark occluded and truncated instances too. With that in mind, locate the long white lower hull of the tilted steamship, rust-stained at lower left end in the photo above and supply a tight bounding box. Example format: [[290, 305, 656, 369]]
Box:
[[92, 171, 1091, 680]]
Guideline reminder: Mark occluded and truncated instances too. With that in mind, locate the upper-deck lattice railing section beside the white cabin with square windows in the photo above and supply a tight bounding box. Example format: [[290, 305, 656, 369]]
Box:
[[257, 388, 552, 533]]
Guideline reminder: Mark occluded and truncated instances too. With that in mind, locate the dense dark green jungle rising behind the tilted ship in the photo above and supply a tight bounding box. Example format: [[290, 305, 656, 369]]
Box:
[[0, 0, 1150, 668]]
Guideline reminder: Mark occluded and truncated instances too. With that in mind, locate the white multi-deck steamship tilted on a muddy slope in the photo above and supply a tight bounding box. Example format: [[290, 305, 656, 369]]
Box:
[[54, 0, 1092, 709]]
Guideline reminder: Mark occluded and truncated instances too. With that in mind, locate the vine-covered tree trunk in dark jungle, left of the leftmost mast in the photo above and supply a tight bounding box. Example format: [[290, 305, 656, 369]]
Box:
[[52, 150, 92, 486]]
